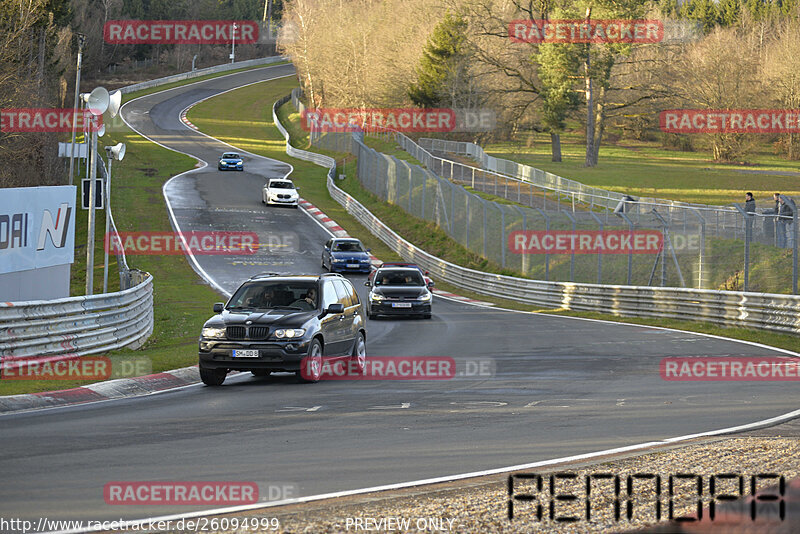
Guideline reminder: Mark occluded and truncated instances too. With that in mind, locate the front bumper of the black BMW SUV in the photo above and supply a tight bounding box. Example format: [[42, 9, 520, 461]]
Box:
[[198, 338, 310, 371]]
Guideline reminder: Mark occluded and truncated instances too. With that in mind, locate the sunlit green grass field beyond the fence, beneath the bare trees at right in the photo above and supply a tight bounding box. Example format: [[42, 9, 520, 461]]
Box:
[[476, 131, 800, 205]]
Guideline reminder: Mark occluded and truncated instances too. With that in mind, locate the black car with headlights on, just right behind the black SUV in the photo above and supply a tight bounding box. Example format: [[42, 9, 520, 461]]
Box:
[[364, 267, 433, 319]]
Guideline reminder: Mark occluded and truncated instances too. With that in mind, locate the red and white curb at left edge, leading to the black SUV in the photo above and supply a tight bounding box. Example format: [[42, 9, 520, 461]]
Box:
[[0, 365, 200, 415]]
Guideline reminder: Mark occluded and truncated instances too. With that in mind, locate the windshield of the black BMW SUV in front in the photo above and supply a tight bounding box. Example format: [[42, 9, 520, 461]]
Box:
[[227, 281, 319, 311]]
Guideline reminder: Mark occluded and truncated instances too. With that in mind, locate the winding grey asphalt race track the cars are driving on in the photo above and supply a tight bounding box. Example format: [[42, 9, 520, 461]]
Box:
[[0, 65, 797, 520]]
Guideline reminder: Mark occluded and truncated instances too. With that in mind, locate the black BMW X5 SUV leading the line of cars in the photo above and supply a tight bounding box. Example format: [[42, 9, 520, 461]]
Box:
[[199, 273, 367, 386]]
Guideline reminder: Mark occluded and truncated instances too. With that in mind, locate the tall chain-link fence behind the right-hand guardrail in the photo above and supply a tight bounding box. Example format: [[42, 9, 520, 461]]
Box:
[[304, 117, 797, 293]]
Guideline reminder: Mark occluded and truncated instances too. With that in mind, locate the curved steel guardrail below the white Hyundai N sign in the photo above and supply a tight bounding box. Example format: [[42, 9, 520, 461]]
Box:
[[0, 270, 153, 374]]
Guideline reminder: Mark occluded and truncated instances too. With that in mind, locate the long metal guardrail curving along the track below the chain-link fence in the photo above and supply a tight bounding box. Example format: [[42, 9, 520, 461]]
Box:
[[273, 92, 800, 334]]
